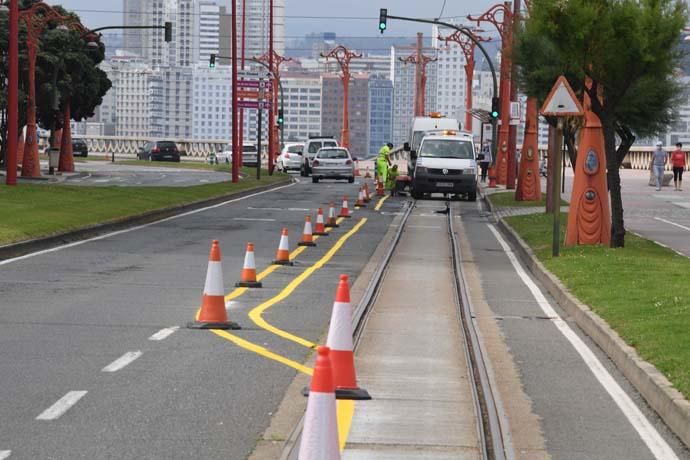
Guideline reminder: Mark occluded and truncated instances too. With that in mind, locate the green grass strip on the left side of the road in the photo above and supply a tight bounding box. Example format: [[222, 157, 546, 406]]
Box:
[[0, 171, 287, 245]]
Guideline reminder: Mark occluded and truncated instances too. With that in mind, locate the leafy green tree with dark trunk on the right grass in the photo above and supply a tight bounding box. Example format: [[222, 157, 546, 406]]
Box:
[[514, 0, 687, 246]]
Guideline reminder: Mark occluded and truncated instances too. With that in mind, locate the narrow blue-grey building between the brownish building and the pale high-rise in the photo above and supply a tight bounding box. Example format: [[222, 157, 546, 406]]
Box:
[[367, 75, 393, 155]]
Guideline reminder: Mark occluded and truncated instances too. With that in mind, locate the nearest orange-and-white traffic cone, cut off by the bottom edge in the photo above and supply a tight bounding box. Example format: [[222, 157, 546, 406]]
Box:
[[298, 347, 340, 460]]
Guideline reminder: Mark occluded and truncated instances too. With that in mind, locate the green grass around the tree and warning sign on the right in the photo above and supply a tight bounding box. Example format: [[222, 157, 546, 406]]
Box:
[[506, 213, 690, 398]]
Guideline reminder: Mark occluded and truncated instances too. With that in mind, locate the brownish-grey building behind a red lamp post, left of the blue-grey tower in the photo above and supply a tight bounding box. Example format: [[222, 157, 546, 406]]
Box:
[[321, 73, 369, 157]]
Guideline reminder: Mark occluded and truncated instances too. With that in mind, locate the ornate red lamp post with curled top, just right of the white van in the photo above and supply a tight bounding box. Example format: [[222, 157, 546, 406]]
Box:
[[467, 2, 515, 188]]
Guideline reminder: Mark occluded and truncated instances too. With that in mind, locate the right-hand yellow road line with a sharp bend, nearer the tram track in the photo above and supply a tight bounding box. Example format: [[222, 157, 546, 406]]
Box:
[[249, 218, 367, 348]]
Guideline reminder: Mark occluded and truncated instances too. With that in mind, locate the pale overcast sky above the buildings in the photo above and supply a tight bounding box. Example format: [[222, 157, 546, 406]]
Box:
[[48, 0, 496, 39]]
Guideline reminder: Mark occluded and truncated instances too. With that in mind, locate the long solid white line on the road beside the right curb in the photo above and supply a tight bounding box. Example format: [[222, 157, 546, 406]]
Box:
[[489, 225, 678, 460]]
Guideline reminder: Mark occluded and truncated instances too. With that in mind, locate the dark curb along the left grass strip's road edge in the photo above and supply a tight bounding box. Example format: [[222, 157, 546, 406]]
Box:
[[0, 178, 293, 260]]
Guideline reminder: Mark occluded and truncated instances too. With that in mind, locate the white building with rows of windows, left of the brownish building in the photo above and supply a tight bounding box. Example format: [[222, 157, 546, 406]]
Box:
[[279, 72, 321, 141]]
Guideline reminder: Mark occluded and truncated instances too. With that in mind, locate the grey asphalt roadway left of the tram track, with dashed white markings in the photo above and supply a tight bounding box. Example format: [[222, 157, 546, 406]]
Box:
[[0, 177, 401, 459]]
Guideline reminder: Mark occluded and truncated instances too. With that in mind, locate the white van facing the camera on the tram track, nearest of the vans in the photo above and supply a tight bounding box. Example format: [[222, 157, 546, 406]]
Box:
[[411, 130, 477, 201]]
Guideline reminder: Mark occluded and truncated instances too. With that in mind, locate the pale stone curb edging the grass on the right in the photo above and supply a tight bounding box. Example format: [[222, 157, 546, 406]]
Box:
[[482, 190, 690, 447]]
